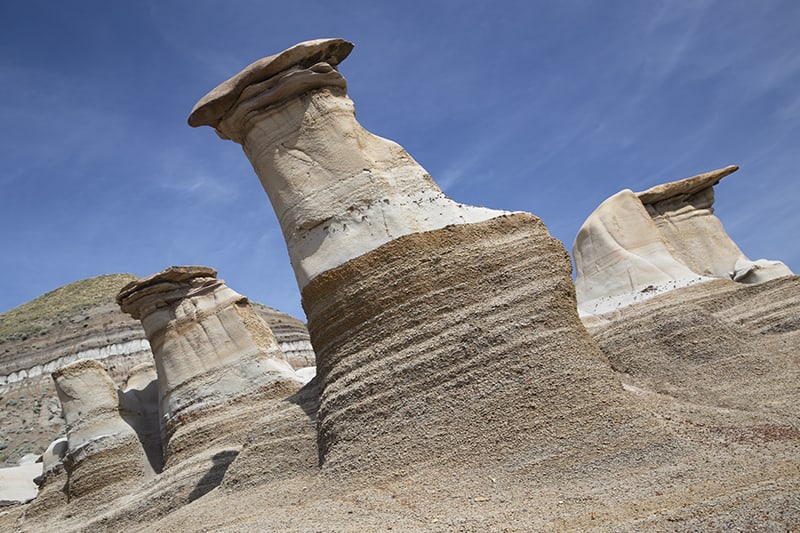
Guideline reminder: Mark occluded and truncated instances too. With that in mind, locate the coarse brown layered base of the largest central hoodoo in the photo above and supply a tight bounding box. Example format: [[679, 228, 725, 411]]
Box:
[[303, 214, 647, 473]]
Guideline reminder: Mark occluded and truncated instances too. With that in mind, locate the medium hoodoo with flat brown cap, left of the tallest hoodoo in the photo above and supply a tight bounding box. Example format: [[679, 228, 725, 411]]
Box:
[[117, 267, 314, 472]]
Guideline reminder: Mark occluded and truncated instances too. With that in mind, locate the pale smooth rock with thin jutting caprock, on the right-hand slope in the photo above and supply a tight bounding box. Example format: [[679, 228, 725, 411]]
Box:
[[572, 166, 792, 314]]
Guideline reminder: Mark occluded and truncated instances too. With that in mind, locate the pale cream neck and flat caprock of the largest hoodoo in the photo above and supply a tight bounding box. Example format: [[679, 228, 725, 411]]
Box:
[[189, 39, 510, 288]]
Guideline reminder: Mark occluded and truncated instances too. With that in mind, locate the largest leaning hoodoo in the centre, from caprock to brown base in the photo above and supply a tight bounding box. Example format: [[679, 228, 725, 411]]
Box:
[[189, 39, 656, 474]]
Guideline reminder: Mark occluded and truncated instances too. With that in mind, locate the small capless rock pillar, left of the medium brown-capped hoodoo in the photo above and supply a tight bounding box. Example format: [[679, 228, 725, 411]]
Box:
[[53, 359, 155, 501]]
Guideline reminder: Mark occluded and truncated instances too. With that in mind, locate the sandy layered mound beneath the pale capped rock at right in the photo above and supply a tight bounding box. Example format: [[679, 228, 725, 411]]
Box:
[[584, 276, 800, 416]]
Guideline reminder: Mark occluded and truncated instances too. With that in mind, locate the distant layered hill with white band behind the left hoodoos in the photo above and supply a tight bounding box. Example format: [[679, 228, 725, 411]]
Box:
[[0, 274, 316, 466]]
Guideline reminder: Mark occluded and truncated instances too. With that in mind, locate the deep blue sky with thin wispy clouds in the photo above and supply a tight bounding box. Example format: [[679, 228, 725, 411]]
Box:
[[0, 0, 800, 318]]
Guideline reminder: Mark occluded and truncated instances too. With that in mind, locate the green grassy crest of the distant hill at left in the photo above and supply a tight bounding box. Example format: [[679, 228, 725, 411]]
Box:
[[0, 274, 139, 340]]
